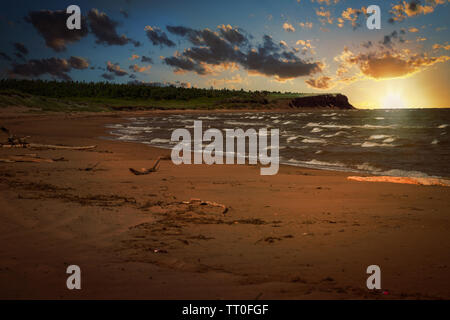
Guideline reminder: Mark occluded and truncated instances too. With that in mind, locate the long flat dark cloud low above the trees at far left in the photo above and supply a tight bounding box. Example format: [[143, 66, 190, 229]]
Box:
[[9, 57, 89, 81]]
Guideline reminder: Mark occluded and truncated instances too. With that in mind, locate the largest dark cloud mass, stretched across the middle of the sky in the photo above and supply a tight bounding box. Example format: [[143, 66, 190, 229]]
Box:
[[164, 26, 322, 80]]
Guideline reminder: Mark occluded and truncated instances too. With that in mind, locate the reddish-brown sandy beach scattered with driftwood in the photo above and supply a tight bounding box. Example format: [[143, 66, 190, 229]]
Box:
[[0, 112, 450, 299]]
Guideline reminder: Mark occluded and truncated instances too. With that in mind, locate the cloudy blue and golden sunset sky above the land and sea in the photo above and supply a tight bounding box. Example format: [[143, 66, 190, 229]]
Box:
[[0, 0, 450, 108]]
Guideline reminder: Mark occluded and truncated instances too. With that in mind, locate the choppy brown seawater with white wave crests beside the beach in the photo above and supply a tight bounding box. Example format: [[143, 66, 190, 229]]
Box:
[[108, 109, 450, 178]]
